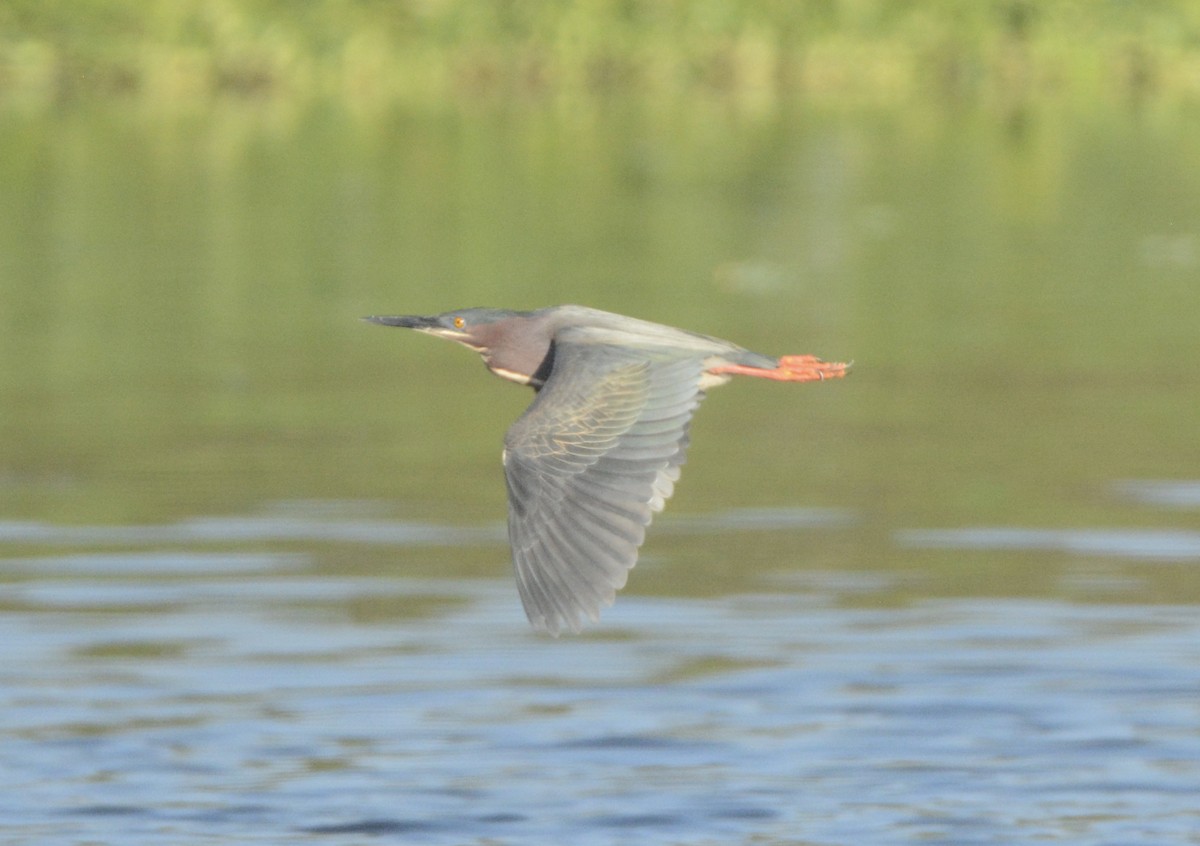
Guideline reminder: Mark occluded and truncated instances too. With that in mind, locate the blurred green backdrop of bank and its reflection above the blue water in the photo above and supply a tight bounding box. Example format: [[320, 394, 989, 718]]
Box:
[[0, 0, 1200, 601]]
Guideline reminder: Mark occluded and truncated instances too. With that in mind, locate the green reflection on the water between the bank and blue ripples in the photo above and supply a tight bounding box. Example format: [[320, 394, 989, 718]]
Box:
[[0, 98, 1200, 613]]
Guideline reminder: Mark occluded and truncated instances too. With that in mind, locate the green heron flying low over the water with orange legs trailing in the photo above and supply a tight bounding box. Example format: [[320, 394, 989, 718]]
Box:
[[364, 306, 847, 635]]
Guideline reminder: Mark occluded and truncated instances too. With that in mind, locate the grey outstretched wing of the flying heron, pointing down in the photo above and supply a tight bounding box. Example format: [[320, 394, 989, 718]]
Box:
[[504, 343, 704, 635]]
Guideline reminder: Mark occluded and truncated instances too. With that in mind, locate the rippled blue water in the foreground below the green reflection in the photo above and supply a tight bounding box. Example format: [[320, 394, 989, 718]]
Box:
[[0, 512, 1200, 845]]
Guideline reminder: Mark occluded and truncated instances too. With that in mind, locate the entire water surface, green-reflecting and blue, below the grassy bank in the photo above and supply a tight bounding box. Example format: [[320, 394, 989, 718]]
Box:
[[0, 67, 1200, 846]]
